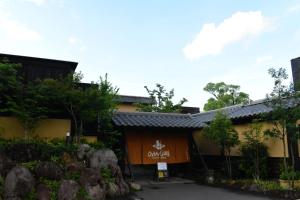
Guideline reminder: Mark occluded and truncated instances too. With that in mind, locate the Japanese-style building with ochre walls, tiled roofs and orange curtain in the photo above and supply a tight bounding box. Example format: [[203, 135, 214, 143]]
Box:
[[0, 54, 300, 177]]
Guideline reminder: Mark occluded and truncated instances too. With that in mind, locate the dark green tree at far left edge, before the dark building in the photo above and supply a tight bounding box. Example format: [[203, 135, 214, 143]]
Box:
[[0, 60, 48, 139]]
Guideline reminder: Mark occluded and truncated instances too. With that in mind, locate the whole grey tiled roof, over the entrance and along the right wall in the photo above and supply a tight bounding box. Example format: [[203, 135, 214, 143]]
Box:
[[113, 100, 296, 128]]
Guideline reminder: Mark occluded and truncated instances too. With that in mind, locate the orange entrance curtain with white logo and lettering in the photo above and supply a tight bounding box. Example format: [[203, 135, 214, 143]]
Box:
[[126, 132, 190, 164]]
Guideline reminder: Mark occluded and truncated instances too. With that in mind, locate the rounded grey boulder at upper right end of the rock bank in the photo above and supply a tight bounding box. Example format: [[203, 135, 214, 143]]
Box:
[[90, 149, 118, 169]]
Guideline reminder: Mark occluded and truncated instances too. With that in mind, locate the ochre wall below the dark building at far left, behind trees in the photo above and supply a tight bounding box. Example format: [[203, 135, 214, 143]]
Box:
[[0, 117, 71, 139]]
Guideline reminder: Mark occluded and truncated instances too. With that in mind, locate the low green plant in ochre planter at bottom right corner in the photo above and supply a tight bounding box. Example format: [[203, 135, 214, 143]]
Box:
[[279, 170, 300, 189]]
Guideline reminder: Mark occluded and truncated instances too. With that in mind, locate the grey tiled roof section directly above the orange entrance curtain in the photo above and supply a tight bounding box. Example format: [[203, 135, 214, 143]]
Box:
[[113, 112, 204, 128]]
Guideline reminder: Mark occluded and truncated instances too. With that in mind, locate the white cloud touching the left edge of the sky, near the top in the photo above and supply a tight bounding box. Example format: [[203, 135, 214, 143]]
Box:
[[0, 6, 42, 41]]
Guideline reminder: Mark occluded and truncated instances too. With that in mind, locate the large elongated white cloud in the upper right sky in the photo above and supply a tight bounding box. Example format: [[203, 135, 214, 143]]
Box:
[[183, 11, 268, 60]]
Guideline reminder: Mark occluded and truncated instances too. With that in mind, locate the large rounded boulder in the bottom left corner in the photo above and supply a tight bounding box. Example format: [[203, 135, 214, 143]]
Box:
[[4, 166, 35, 200]]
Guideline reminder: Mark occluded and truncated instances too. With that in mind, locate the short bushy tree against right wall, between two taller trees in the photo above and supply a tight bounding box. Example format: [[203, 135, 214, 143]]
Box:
[[240, 120, 268, 180]]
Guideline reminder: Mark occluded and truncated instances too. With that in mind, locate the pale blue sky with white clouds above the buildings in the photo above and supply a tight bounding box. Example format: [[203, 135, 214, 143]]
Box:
[[0, 0, 300, 110]]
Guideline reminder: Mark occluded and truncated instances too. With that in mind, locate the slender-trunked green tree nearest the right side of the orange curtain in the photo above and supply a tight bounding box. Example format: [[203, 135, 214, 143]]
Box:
[[204, 112, 239, 178]]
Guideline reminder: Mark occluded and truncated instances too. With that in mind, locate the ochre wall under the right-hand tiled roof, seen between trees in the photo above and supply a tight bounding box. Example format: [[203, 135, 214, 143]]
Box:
[[193, 123, 288, 157]]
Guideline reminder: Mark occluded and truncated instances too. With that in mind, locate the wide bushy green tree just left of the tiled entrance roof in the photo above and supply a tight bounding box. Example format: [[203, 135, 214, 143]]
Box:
[[42, 73, 118, 141]]
